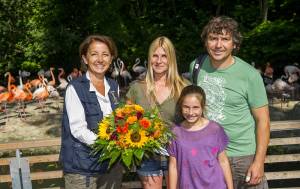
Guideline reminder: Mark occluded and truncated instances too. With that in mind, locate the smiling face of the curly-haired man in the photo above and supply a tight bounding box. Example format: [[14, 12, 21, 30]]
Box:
[[206, 30, 235, 64]]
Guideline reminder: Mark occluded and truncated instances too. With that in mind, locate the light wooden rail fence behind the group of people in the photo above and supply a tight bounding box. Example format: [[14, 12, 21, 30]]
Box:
[[0, 120, 300, 189]]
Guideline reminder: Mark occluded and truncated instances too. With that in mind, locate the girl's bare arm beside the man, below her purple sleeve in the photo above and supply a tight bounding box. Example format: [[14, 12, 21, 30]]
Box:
[[218, 151, 233, 189]]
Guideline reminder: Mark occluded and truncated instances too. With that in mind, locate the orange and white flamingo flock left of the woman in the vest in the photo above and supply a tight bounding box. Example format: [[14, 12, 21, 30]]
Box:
[[0, 67, 81, 122]]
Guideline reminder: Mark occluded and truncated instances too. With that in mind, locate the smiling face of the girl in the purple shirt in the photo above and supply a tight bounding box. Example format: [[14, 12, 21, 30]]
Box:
[[181, 94, 203, 125]]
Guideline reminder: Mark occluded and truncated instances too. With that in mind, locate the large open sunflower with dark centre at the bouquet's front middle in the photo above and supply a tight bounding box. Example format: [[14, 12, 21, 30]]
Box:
[[124, 131, 149, 148]]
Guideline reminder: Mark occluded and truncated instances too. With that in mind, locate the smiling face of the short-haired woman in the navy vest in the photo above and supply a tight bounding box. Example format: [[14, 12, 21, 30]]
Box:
[[82, 41, 113, 76]]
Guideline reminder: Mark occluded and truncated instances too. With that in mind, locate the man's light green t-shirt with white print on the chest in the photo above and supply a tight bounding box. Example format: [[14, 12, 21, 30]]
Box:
[[190, 57, 268, 156]]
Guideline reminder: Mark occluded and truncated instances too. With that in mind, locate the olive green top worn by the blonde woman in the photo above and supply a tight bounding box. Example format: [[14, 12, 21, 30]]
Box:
[[126, 81, 176, 123]]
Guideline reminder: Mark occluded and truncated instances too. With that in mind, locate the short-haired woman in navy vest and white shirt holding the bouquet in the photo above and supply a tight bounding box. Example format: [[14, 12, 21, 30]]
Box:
[[60, 35, 123, 189]]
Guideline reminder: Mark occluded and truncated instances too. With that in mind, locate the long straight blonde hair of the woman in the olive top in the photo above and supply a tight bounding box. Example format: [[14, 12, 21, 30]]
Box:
[[145, 36, 187, 99]]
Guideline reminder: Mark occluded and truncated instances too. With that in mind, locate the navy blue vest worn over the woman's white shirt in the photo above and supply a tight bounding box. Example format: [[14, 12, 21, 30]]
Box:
[[60, 75, 118, 176]]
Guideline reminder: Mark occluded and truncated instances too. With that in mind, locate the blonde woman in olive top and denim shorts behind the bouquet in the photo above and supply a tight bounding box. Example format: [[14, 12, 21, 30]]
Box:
[[126, 36, 189, 189]]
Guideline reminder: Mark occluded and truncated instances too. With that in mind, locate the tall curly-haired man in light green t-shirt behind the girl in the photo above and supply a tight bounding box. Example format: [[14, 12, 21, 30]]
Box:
[[190, 16, 270, 189]]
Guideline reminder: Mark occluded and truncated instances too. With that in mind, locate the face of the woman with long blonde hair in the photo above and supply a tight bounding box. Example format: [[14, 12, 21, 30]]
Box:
[[151, 47, 169, 75]]
